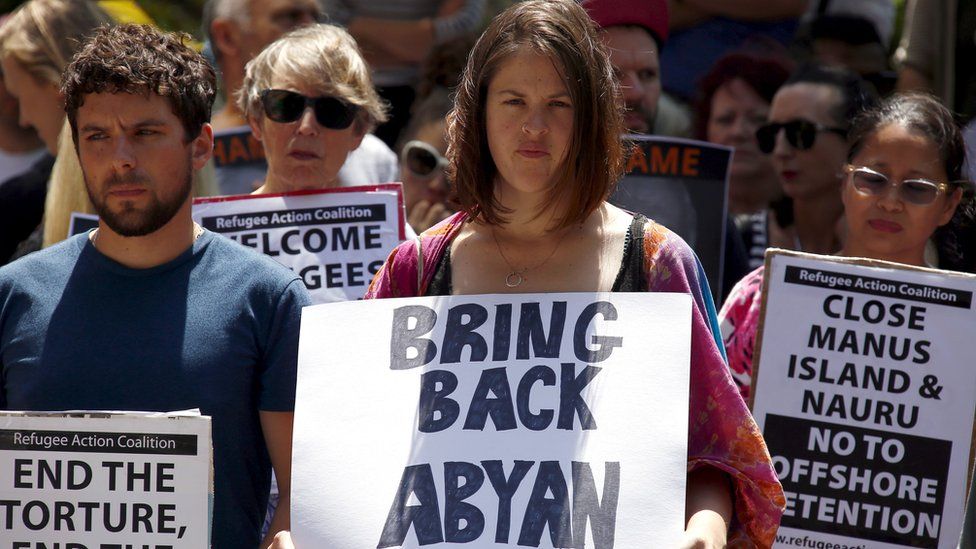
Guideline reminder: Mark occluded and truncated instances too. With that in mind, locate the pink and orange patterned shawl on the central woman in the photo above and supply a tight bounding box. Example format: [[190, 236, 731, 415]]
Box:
[[365, 212, 785, 547]]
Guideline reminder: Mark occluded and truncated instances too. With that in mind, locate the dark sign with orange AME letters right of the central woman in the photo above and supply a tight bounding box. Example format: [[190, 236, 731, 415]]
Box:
[[610, 135, 732, 296]]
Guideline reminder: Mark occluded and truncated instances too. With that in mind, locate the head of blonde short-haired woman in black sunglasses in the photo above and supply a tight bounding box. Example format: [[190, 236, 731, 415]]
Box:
[[237, 25, 386, 194]]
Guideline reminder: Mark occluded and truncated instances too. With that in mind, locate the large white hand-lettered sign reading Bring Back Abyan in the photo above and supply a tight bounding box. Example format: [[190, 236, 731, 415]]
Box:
[[291, 293, 691, 549]]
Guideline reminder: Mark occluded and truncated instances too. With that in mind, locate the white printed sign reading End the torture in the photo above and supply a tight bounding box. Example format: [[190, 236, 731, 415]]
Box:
[[0, 412, 213, 549]]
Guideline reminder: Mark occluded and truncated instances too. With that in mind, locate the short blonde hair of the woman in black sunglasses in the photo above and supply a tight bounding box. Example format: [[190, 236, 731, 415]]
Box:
[[237, 24, 388, 132]]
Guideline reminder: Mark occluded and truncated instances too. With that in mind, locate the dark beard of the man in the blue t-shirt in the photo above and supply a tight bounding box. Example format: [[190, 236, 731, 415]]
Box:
[[85, 162, 193, 237]]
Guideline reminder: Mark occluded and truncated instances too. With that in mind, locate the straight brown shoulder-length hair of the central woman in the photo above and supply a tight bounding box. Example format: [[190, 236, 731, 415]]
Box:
[[447, 0, 625, 228]]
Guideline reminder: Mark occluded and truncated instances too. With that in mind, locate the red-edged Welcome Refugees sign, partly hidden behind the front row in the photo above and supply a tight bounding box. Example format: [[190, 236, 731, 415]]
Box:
[[193, 183, 405, 303]]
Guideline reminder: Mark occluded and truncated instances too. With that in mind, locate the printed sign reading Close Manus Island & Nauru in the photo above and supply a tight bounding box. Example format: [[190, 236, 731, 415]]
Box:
[[753, 251, 976, 548]]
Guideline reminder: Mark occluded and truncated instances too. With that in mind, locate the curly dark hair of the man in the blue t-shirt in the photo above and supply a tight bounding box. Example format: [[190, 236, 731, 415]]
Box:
[[61, 25, 217, 148]]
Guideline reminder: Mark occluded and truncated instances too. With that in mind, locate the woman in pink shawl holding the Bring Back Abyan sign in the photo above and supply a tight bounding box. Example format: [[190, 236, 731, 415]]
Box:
[[352, 0, 784, 547]]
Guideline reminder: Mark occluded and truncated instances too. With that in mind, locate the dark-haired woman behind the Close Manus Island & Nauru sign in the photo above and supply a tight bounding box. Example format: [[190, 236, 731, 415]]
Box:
[[719, 90, 974, 396]]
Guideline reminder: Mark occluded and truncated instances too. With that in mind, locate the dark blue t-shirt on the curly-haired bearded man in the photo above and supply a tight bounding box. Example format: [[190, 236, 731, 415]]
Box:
[[0, 231, 309, 549]]
